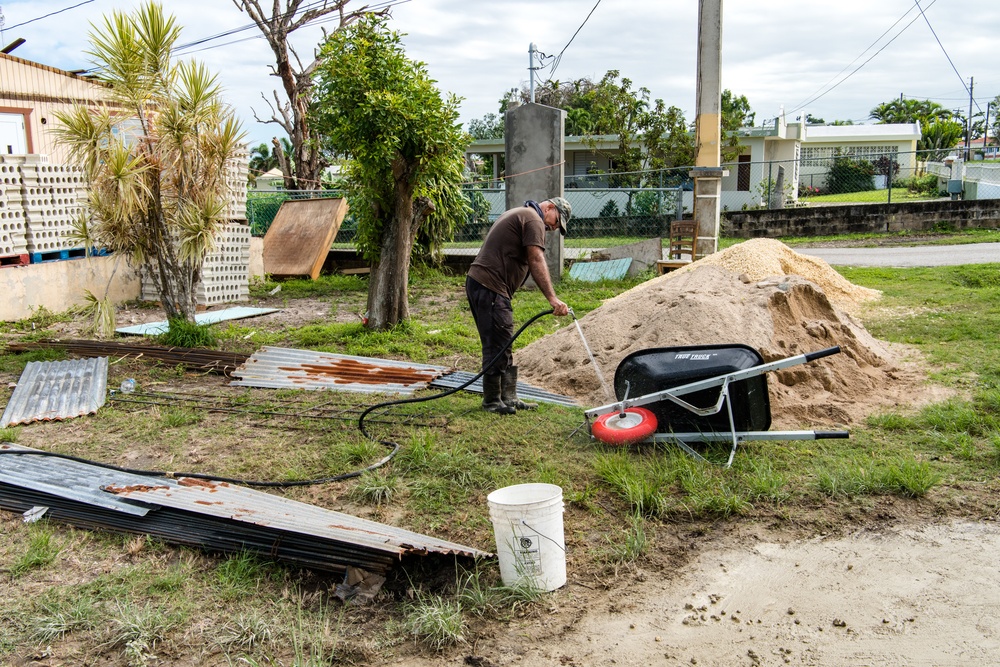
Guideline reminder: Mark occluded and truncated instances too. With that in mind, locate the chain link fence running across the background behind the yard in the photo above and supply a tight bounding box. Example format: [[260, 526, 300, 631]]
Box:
[[247, 153, 1000, 244]]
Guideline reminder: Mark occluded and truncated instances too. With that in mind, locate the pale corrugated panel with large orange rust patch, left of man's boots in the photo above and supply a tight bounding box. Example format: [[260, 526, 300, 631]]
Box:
[[230, 346, 448, 394]]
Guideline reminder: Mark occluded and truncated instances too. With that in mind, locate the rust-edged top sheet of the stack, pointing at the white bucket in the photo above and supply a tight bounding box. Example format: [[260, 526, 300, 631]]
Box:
[[105, 477, 489, 558]]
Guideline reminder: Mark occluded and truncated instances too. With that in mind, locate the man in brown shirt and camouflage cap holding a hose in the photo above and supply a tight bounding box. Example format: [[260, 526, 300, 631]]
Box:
[[465, 197, 572, 415]]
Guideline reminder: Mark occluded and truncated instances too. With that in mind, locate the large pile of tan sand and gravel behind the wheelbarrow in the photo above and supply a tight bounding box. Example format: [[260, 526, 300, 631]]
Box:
[[515, 240, 922, 428]]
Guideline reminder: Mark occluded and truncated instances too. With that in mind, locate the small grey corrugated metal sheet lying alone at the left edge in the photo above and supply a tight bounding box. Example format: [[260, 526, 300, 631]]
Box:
[[0, 357, 108, 428]]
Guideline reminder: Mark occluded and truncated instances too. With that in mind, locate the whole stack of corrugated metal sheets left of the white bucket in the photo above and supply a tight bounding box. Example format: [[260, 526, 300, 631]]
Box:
[[0, 445, 489, 572]]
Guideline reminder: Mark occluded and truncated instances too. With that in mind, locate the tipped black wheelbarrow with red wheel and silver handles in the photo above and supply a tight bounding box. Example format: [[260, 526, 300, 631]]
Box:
[[584, 345, 849, 467]]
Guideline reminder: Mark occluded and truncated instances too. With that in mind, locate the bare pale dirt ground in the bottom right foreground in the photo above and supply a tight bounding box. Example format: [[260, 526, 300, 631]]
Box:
[[403, 520, 1000, 667]]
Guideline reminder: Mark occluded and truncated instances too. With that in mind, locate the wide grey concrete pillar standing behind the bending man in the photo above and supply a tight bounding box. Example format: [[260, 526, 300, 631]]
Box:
[[504, 104, 566, 282]]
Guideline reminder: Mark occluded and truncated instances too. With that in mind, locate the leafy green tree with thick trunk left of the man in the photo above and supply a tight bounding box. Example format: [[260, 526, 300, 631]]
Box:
[[311, 16, 469, 330]]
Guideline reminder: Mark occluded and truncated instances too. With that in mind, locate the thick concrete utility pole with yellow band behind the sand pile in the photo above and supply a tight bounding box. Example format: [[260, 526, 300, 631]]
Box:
[[690, 0, 729, 259]]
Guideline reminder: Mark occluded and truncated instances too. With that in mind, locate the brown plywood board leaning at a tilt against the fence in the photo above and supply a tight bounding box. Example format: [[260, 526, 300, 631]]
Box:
[[264, 199, 347, 280]]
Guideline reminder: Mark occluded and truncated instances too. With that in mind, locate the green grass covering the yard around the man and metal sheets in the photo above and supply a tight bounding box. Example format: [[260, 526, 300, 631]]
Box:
[[0, 254, 1000, 665]]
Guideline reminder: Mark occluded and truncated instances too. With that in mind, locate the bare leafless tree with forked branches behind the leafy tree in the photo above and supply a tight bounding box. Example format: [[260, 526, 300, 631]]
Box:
[[233, 0, 388, 190]]
